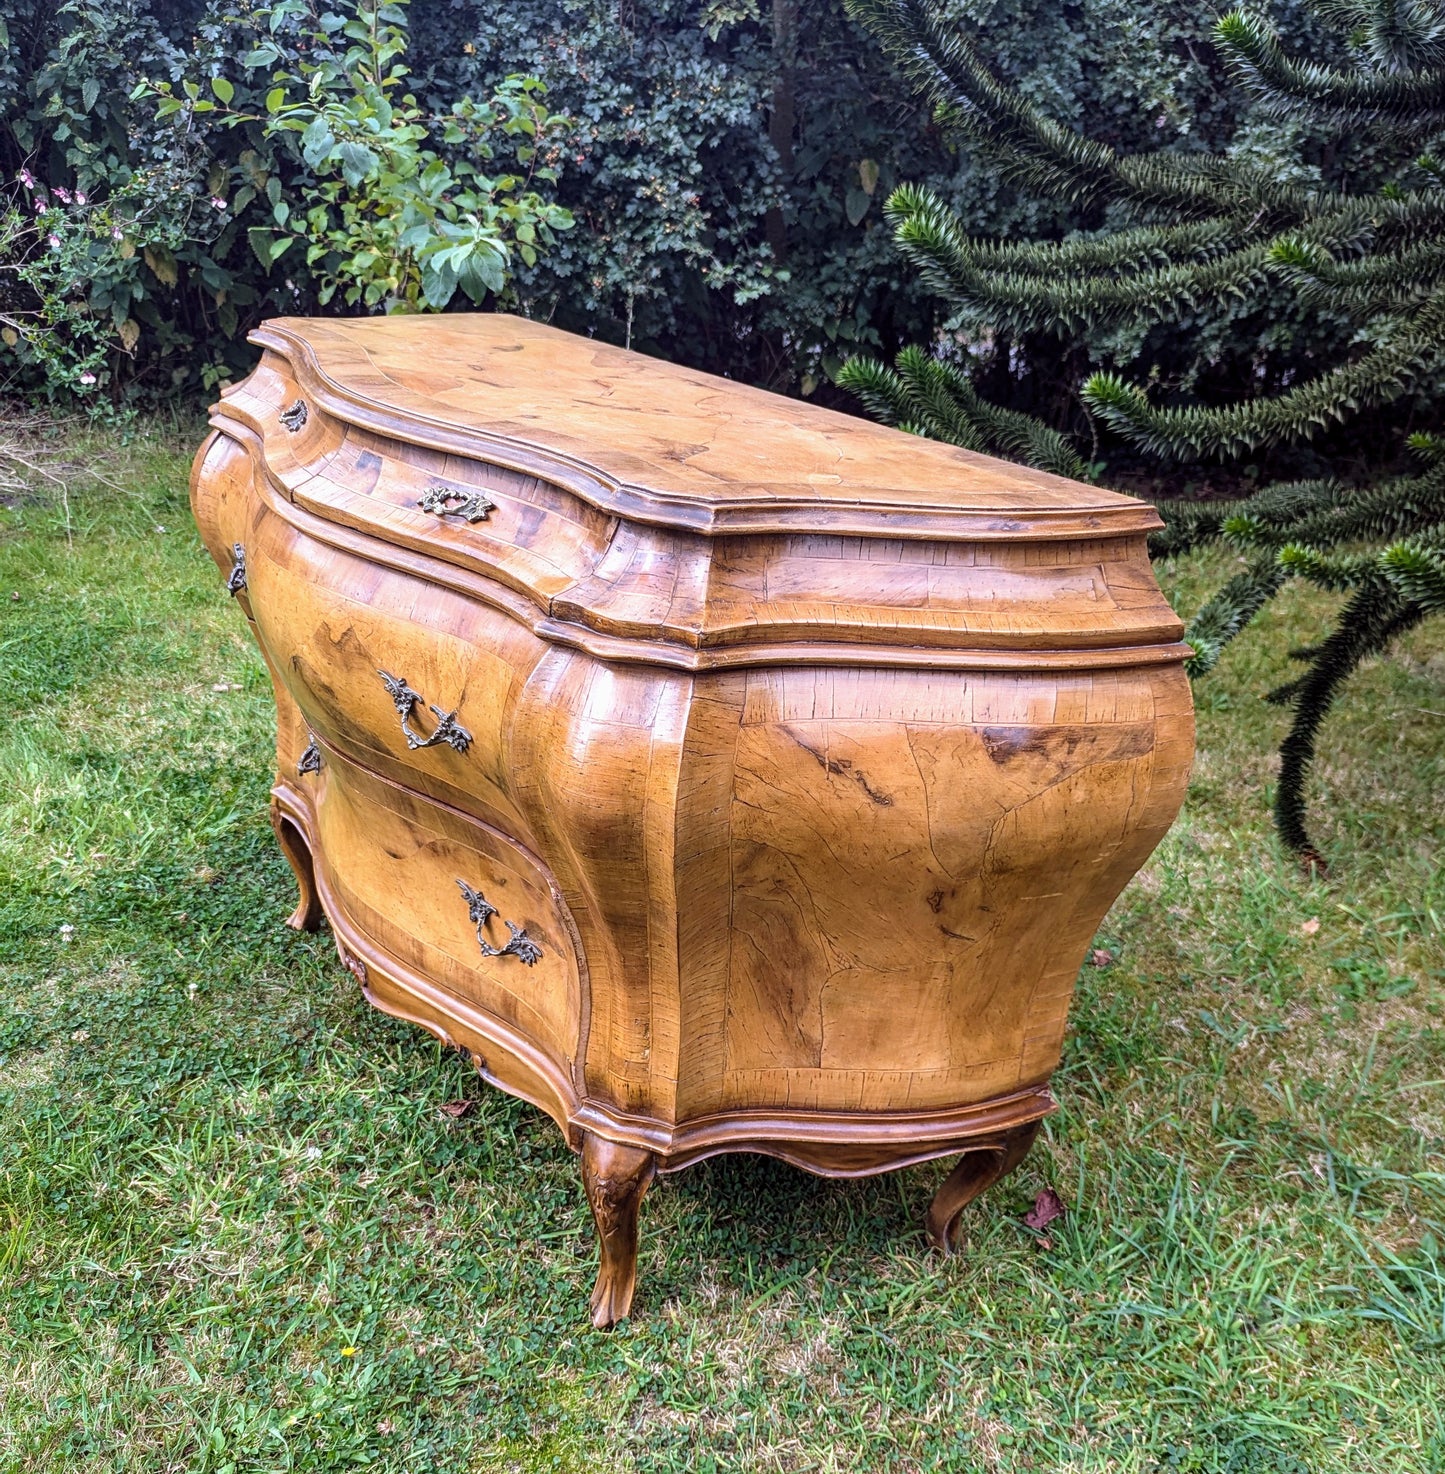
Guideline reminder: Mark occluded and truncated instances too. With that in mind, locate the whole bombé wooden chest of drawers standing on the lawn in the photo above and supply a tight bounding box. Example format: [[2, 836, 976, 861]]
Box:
[[192, 315, 1193, 1325]]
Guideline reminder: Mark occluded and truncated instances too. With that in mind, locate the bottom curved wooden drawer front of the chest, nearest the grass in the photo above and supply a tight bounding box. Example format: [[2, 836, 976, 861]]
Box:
[[314, 752, 584, 1072]]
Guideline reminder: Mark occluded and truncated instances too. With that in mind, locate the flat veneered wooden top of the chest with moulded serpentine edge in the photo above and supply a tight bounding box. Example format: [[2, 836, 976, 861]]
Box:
[[251, 312, 1162, 541]]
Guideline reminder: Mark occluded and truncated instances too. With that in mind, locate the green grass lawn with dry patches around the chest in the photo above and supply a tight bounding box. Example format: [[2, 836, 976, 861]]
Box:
[[0, 412, 1445, 1474]]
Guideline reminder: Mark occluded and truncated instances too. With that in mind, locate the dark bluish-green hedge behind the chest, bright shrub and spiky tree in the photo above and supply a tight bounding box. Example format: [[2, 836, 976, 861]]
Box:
[[0, 0, 1295, 407]]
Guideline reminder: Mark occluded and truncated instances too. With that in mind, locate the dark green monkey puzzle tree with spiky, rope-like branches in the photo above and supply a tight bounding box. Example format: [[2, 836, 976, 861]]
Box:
[[839, 0, 1445, 865]]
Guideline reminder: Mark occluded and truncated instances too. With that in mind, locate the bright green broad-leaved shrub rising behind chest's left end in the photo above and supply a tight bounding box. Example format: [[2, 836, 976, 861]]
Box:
[[146, 0, 572, 311]]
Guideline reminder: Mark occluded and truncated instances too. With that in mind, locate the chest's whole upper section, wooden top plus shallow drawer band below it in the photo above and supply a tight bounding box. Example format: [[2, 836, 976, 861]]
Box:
[[211, 314, 1188, 671]]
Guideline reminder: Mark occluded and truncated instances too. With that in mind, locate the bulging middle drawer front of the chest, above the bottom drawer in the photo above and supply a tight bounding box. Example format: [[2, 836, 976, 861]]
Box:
[[246, 509, 546, 839]]
